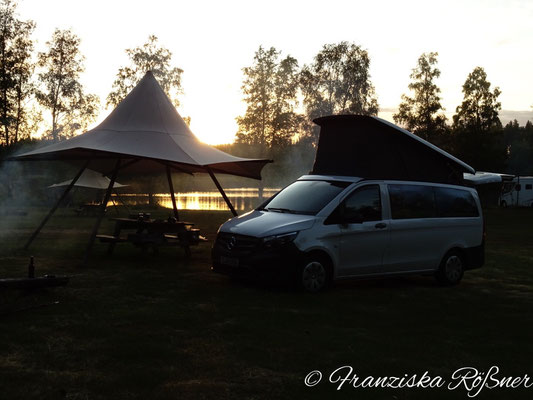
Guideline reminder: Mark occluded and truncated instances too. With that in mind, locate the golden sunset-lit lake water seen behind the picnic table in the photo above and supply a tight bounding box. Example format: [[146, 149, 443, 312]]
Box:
[[109, 188, 279, 211]]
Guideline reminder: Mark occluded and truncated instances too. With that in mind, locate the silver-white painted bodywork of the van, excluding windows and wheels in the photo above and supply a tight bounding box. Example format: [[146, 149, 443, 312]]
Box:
[[213, 175, 483, 279]]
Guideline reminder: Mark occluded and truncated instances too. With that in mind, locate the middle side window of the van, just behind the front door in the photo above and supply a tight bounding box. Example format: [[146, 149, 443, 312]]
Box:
[[389, 185, 436, 219]]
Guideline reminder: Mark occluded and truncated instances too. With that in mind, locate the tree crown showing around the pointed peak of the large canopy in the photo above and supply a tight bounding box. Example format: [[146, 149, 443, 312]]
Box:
[[107, 35, 183, 107]]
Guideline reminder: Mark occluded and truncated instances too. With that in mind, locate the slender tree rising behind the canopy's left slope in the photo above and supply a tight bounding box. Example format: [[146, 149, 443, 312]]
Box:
[[36, 29, 100, 141]]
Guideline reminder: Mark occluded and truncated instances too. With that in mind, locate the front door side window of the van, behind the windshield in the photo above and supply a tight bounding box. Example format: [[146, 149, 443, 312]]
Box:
[[341, 185, 382, 223]]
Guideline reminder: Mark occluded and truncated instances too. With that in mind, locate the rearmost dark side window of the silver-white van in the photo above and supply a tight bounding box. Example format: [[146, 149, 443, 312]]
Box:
[[434, 187, 479, 217]]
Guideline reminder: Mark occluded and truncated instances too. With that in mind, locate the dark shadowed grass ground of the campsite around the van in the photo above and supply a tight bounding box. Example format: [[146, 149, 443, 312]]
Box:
[[0, 209, 533, 400]]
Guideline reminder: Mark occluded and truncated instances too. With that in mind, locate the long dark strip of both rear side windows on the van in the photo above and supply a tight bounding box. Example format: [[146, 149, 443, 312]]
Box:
[[389, 185, 479, 219]]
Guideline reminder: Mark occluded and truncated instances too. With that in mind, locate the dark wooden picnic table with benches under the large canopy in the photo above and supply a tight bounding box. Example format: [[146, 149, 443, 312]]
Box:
[[96, 213, 206, 257]]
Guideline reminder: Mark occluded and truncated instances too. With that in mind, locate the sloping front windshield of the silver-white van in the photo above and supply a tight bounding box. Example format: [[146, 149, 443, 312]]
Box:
[[258, 181, 351, 215]]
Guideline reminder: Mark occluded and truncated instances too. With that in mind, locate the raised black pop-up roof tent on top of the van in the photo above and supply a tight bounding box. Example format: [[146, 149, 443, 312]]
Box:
[[311, 115, 475, 185]]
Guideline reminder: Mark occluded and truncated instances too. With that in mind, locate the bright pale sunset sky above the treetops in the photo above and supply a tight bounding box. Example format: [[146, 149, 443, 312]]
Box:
[[18, 0, 533, 144]]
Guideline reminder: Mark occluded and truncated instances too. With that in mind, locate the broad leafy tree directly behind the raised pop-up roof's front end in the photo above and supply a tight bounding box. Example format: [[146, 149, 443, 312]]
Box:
[[300, 42, 379, 119]]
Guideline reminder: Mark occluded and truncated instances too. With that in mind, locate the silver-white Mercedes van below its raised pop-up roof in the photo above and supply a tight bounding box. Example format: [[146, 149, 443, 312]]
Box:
[[212, 175, 484, 292]]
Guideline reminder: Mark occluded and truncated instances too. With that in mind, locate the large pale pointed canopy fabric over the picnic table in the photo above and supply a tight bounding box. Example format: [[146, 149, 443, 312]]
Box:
[[12, 71, 272, 179]]
